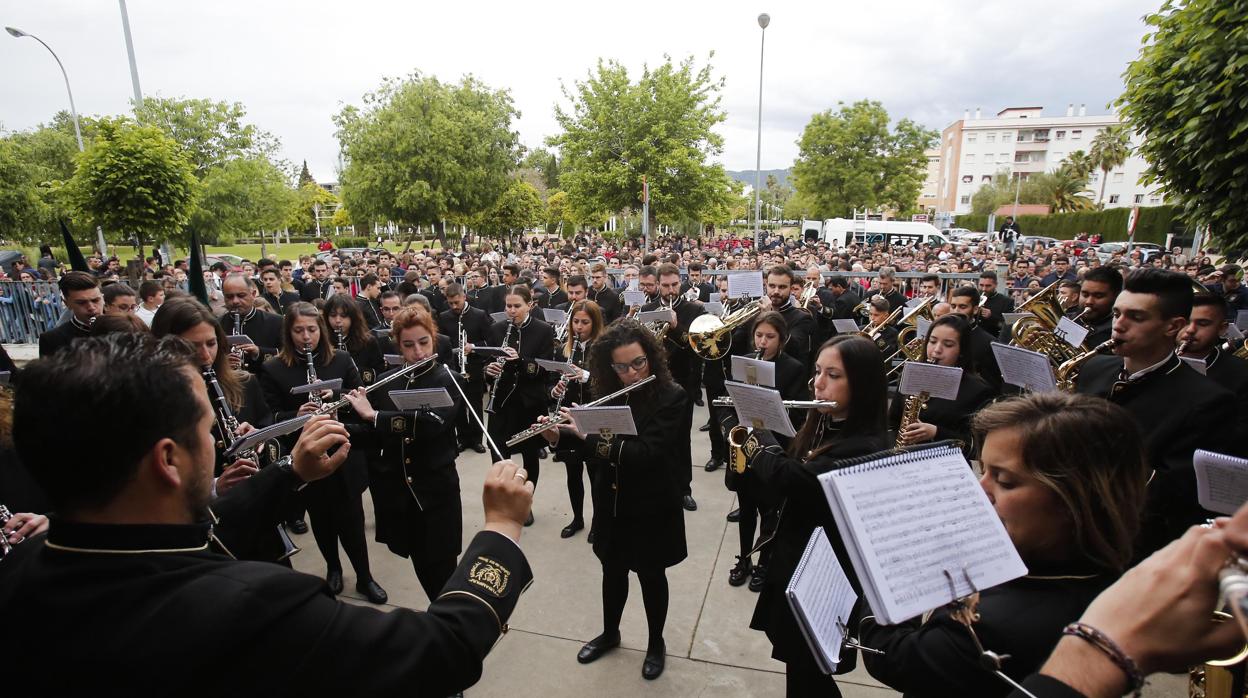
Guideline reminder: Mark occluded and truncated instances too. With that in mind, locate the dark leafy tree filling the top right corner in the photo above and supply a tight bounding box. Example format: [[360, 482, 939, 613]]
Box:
[[1118, 0, 1248, 255]]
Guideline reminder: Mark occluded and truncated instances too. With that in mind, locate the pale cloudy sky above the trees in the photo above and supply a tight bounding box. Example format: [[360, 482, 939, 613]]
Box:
[[0, 0, 1161, 181]]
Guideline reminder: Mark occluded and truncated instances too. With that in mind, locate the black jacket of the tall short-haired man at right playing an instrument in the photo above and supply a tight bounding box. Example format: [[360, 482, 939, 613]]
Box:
[[1076, 355, 1239, 558]]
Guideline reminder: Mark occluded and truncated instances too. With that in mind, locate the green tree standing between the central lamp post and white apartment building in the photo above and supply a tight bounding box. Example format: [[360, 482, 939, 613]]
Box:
[[792, 100, 938, 219]]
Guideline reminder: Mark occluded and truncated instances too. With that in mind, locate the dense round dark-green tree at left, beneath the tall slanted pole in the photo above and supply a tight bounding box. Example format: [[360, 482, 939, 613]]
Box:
[[69, 120, 200, 245]]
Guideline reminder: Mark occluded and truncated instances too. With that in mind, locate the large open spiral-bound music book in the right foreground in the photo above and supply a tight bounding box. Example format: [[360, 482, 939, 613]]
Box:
[[819, 441, 1027, 624]]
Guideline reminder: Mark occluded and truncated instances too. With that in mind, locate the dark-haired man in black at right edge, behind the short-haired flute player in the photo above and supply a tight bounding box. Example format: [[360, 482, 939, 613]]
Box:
[[1179, 295, 1248, 442]]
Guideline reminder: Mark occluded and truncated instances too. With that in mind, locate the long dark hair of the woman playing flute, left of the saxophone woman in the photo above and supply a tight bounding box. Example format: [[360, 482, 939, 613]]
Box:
[[789, 335, 889, 457]]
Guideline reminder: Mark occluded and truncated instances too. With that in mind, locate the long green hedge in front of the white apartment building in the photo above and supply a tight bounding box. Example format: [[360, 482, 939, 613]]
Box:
[[953, 206, 1186, 245]]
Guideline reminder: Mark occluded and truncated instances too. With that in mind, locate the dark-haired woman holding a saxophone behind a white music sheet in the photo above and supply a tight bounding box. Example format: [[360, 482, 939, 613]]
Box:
[[889, 313, 995, 448]]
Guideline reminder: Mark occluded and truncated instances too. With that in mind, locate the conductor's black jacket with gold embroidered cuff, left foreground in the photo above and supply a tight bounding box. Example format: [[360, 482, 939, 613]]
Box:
[[0, 519, 533, 698]]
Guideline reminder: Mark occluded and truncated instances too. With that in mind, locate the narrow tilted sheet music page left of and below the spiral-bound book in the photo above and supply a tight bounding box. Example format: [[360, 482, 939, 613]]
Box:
[[785, 527, 857, 674]]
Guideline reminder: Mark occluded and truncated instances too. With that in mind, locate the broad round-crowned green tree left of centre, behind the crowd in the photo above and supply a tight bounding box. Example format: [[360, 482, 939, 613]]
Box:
[[334, 72, 520, 245]]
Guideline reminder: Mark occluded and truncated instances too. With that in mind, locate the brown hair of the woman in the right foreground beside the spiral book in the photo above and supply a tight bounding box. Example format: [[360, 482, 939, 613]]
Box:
[[971, 392, 1148, 572]]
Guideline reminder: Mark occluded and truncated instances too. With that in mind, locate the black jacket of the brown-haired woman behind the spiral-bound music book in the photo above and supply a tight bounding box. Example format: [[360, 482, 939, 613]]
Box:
[[859, 564, 1117, 697]]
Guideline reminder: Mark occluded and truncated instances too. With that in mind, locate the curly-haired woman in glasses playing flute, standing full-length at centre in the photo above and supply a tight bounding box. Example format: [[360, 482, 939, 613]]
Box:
[[542, 319, 689, 679]]
